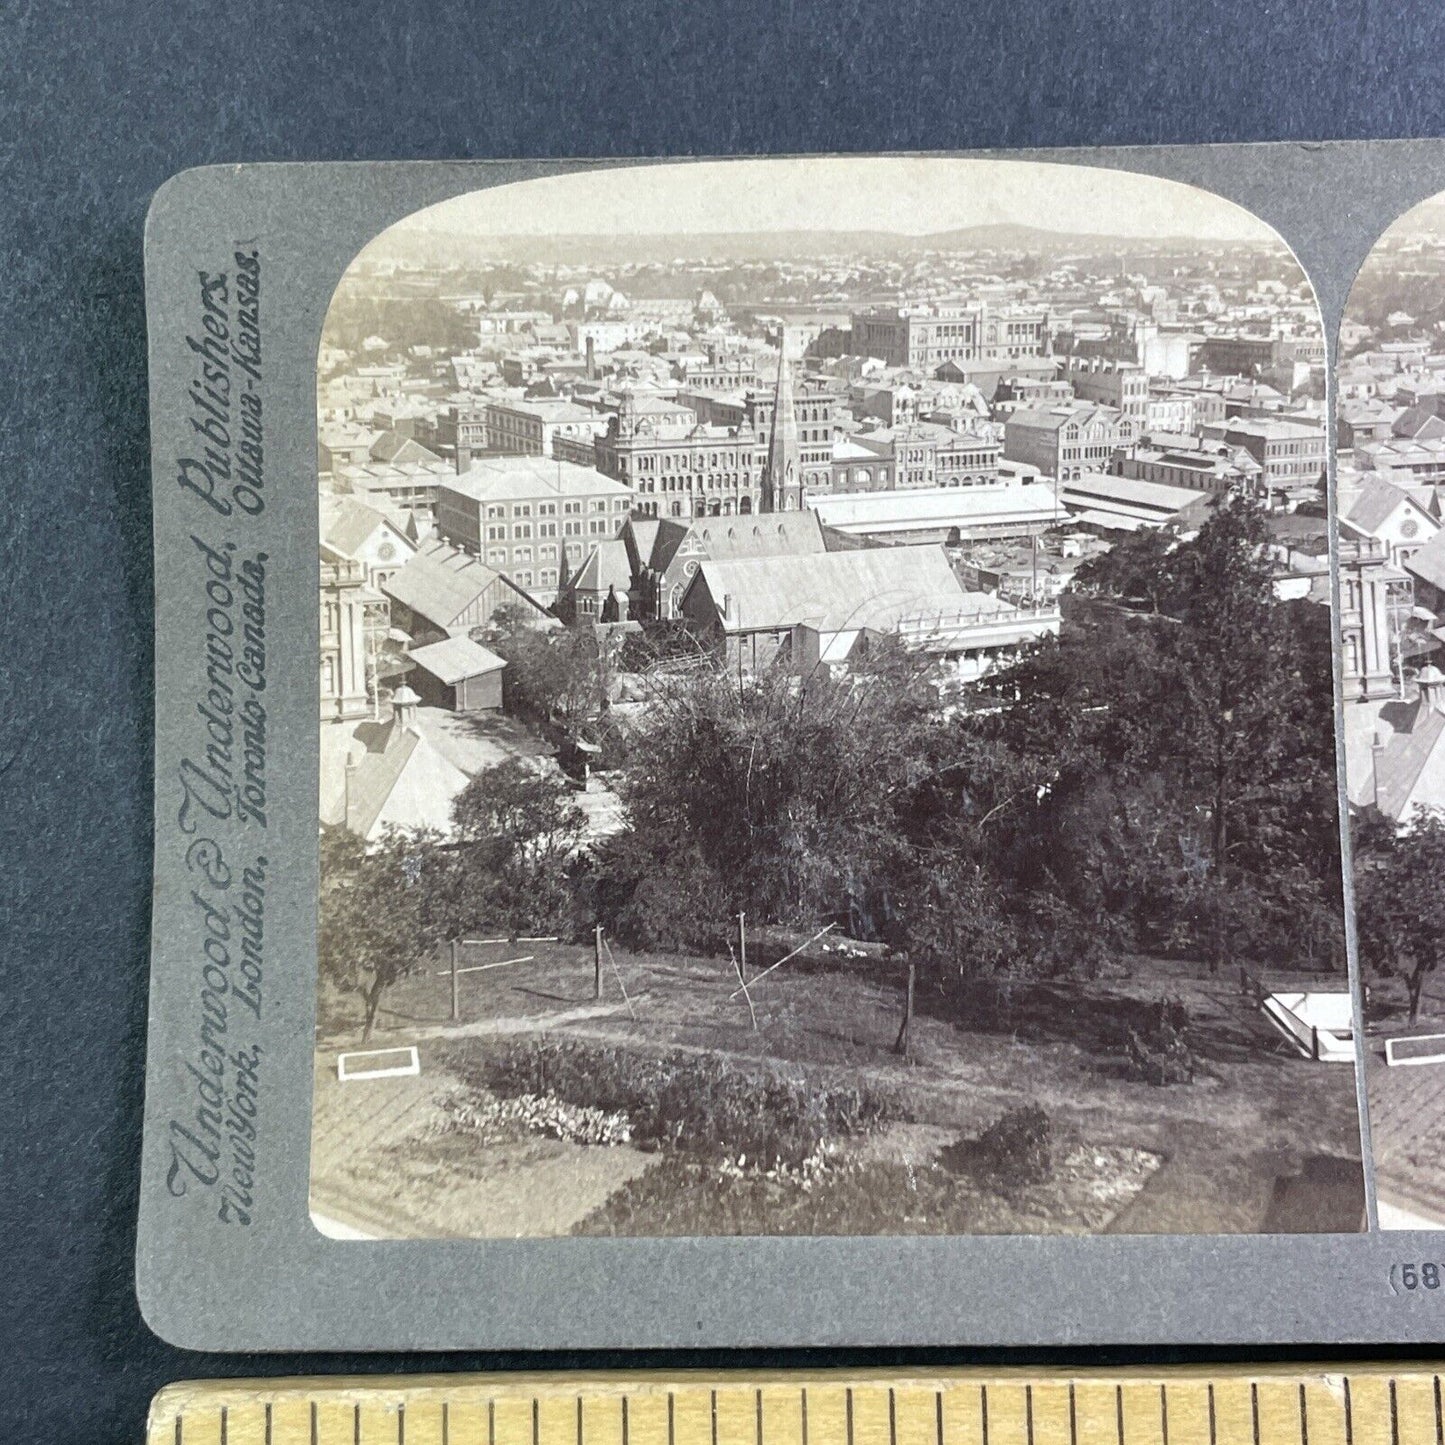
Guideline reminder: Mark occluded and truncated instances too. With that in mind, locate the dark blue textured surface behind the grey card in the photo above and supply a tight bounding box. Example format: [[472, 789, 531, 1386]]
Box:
[[0, 0, 1445, 1442]]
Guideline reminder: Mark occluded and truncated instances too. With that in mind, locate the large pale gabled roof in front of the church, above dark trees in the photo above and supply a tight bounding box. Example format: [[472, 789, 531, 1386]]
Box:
[[683, 546, 984, 633]]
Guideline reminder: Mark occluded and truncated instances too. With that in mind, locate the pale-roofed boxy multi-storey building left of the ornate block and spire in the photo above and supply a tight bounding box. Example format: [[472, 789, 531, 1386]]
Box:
[[436, 457, 633, 605]]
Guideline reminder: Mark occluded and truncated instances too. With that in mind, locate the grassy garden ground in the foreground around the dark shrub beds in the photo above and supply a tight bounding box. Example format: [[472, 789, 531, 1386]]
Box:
[[314, 942, 1360, 1234]]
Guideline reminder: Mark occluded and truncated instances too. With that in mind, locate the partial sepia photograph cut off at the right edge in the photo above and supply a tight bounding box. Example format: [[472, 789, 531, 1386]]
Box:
[[1337, 197, 1445, 1230]]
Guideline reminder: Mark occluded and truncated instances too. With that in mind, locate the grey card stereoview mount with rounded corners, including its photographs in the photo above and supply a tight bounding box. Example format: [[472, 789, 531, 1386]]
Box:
[[137, 142, 1445, 1350]]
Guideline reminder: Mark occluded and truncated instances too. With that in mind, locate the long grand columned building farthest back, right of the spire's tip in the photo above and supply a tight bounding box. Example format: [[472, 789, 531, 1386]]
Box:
[[853, 301, 1049, 371]]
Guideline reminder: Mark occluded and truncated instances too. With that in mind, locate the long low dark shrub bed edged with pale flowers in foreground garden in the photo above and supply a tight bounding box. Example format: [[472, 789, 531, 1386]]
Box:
[[448, 1035, 889, 1166]]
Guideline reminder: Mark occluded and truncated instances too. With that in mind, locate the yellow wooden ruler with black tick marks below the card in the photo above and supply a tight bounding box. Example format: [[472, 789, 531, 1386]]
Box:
[[147, 1364, 1445, 1445]]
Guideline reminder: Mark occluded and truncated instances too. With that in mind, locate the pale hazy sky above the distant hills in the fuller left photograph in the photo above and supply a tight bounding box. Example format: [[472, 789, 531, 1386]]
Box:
[[373, 156, 1277, 244]]
